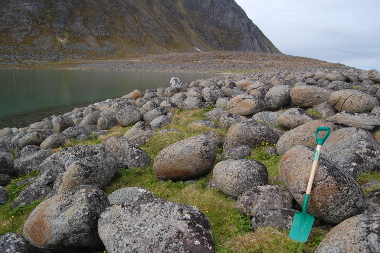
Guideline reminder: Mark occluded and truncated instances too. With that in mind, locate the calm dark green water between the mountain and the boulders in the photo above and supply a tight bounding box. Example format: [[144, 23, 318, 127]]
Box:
[[0, 70, 217, 129]]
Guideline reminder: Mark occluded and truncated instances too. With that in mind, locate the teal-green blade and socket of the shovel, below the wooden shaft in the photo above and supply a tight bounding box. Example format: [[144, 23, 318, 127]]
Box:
[[289, 194, 314, 243]]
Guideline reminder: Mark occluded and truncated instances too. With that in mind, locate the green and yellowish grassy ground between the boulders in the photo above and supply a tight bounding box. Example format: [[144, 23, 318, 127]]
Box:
[[0, 108, 380, 253]]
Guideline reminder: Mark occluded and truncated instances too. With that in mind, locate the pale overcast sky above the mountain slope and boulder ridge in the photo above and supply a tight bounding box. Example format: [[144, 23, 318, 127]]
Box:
[[235, 0, 380, 70]]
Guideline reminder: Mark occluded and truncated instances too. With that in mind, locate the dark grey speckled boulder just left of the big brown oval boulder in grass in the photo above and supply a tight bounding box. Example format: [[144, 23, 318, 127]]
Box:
[[104, 136, 150, 169]]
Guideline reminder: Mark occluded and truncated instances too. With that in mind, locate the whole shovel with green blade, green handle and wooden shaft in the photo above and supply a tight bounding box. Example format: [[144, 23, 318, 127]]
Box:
[[289, 127, 330, 243]]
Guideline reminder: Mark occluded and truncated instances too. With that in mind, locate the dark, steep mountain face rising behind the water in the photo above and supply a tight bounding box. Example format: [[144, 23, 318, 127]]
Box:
[[0, 0, 279, 59]]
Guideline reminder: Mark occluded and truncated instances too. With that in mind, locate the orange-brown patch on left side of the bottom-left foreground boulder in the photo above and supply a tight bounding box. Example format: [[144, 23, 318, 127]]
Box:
[[24, 201, 52, 247]]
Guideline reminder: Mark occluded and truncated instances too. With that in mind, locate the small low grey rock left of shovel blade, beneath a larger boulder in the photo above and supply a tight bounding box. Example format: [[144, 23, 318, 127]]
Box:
[[252, 208, 295, 230]]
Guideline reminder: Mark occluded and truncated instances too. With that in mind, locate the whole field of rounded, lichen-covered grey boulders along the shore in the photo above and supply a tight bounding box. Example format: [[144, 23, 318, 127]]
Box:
[[0, 68, 380, 252]]
